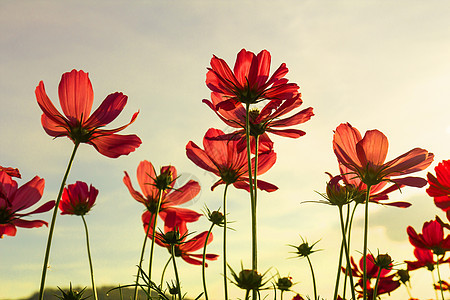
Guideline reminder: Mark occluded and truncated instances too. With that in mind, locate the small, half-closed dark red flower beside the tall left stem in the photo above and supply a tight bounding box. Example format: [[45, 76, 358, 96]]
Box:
[[59, 181, 98, 216]]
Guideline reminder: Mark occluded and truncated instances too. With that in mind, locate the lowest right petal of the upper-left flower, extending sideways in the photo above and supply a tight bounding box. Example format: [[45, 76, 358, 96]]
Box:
[[88, 134, 142, 158]]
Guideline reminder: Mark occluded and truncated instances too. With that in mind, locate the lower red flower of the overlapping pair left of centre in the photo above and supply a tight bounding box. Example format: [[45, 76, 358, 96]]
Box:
[[142, 212, 219, 267]]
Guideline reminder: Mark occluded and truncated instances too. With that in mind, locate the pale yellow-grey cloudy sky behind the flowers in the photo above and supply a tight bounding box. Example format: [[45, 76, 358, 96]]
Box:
[[0, 0, 450, 299]]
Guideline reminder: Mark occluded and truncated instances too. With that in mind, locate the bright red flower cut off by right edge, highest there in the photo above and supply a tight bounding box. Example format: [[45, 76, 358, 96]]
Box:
[[427, 160, 450, 218]]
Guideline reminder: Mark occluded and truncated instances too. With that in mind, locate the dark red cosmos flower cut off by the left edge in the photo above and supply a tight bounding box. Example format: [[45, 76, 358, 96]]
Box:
[[0, 171, 55, 238]]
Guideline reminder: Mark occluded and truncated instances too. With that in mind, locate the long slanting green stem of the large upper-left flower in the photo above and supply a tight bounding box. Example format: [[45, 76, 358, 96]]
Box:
[[39, 142, 80, 300]]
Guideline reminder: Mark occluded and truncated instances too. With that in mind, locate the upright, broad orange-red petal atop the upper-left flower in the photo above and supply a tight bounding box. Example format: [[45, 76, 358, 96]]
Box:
[[58, 70, 94, 121]]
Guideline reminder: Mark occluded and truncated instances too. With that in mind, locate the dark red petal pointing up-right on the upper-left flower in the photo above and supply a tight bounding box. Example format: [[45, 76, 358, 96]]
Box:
[[84, 93, 128, 128]]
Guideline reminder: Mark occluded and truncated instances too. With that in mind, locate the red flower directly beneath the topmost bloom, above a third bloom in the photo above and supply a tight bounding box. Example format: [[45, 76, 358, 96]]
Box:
[[203, 92, 314, 148]]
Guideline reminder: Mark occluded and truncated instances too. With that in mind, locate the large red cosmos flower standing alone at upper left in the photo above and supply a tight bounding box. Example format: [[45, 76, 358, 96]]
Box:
[[35, 70, 141, 158]]
